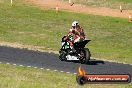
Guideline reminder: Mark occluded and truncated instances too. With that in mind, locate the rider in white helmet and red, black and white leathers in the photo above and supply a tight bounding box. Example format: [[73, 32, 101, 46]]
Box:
[[64, 21, 85, 49]]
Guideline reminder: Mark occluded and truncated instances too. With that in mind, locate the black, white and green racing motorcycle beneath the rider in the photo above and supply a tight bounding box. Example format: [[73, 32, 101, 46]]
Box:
[[59, 33, 91, 64]]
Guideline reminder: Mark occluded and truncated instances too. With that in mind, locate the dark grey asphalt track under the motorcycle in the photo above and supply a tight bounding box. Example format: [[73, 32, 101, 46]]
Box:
[[0, 46, 132, 80]]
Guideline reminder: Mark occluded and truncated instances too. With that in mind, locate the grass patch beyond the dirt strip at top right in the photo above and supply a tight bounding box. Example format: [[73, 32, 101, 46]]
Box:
[[65, 0, 132, 10]]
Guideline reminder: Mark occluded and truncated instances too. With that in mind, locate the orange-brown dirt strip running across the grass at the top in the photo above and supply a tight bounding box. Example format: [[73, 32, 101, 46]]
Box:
[[25, 0, 132, 18]]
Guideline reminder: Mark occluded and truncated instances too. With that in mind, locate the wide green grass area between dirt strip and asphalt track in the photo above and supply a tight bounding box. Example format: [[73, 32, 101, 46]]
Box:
[[0, 0, 132, 63]]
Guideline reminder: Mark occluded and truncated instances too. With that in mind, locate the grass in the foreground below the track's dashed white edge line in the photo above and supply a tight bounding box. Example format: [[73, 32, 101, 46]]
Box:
[[0, 64, 132, 88]]
